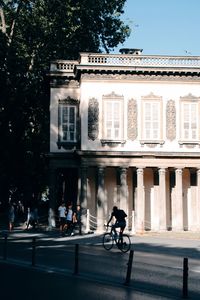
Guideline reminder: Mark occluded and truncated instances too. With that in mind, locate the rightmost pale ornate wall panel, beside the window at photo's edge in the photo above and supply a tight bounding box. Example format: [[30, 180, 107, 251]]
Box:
[[166, 100, 176, 141]]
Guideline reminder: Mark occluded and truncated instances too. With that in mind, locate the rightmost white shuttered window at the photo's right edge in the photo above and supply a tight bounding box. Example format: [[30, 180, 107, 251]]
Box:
[[181, 102, 198, 141]]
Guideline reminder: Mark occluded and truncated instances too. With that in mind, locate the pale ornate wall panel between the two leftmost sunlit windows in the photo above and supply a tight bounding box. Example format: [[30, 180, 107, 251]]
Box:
[[127, 99, 137, 141]]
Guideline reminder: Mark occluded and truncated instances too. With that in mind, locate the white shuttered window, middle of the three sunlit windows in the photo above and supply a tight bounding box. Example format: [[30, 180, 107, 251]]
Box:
[[143, 100, 161, 140]]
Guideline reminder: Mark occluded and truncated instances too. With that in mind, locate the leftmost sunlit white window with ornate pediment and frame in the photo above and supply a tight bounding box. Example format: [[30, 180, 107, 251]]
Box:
[[103, 93, 123, 141]]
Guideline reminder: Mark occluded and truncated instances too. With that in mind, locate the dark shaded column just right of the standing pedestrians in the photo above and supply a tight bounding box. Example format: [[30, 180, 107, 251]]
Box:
[[80, 165, 87, 232]]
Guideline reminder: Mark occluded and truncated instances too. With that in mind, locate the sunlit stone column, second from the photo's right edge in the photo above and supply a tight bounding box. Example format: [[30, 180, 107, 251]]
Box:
[[172, 169, 183, 231]]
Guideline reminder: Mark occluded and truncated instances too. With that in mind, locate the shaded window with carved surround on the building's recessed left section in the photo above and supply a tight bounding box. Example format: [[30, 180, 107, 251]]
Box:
[[57, 97, 78, 149]]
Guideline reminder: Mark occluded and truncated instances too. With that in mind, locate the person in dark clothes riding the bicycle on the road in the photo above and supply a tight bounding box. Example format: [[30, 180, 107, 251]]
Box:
[[107, 206, 127, 237]]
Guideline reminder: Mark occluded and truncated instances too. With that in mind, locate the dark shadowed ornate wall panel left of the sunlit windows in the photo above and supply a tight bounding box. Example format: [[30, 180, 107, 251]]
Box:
[[88, 98, 99, 141]]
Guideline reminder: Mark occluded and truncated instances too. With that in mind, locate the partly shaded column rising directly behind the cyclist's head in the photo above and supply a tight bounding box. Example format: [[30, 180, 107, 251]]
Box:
[[120, 167, 128, 214]]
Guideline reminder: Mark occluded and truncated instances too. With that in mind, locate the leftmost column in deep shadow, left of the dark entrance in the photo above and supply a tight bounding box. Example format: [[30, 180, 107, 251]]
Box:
[[48, 168, 57, 229]]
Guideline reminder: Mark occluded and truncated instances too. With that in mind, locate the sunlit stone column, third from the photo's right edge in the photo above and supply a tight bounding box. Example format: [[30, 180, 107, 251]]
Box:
[[159, 168, 167, 230]]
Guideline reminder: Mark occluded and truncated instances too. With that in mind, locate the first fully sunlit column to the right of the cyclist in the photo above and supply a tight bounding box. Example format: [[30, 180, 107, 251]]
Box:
[[135, 168, 145, 232]]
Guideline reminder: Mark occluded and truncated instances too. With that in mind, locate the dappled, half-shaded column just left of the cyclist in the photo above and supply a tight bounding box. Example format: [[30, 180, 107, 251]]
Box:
[[97, 167, 107, 231]]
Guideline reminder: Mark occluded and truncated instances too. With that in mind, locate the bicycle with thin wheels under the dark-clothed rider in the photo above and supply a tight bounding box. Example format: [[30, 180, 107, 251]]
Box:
[[102, 225, 131, 253]]
